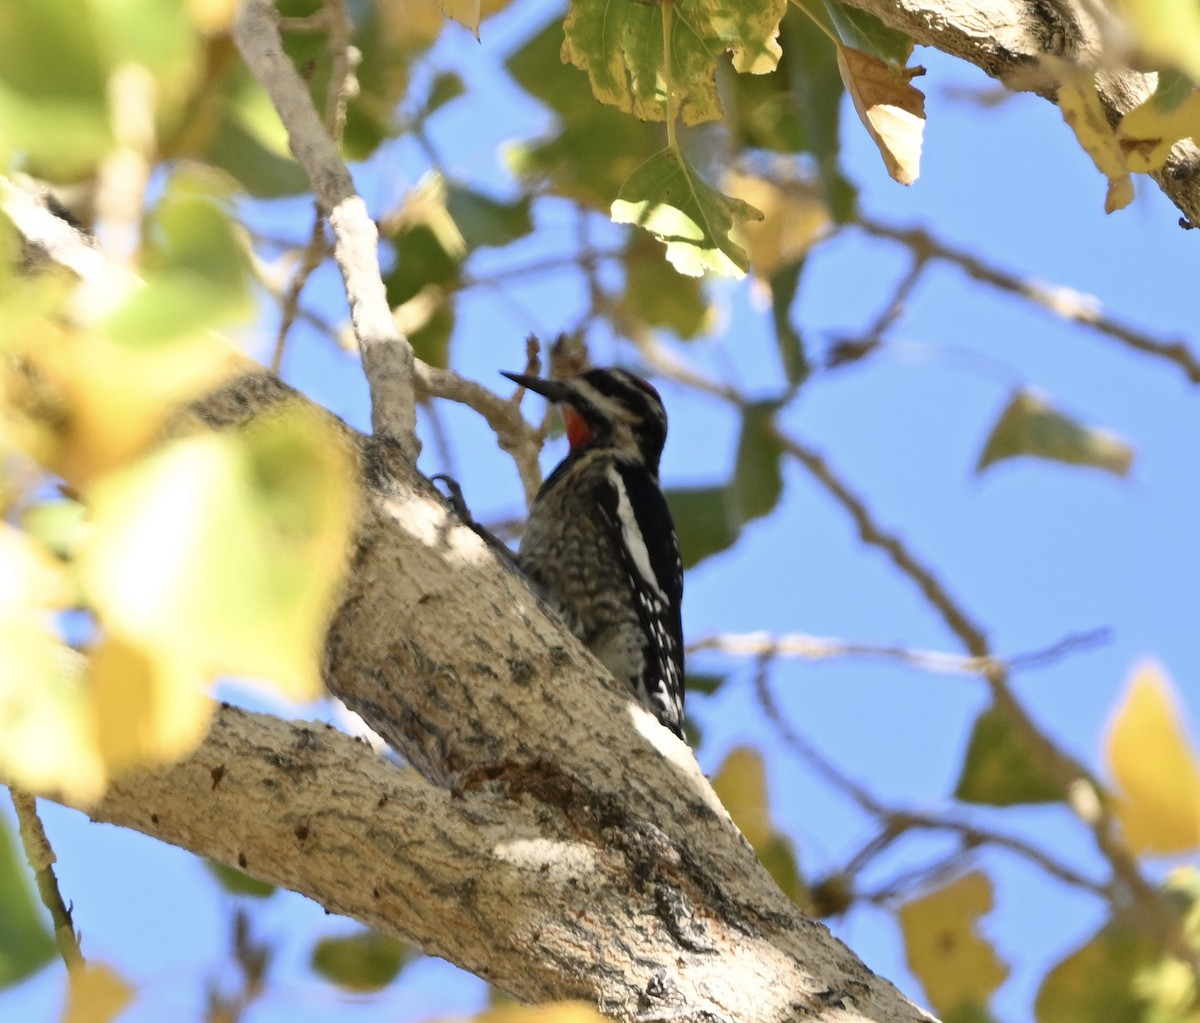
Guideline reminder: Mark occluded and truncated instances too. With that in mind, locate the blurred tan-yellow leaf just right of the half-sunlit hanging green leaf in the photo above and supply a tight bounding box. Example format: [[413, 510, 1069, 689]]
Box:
[[725, 174, 829, 281]]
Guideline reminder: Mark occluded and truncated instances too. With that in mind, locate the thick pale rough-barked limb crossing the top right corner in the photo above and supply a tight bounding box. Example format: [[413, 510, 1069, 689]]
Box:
[[847, 0, 1200, 225]]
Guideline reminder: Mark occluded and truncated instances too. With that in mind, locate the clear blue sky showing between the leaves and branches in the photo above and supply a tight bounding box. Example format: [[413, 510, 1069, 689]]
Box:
[[0, 4, 1200, 1023]]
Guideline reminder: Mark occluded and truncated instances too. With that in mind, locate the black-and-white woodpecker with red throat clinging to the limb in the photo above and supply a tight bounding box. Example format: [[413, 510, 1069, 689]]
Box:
[[504, 369, 684, 737]]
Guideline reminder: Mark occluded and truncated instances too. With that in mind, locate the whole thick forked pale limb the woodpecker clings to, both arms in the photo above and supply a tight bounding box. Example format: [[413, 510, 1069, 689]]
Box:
[[7, 187, 928, 1023]]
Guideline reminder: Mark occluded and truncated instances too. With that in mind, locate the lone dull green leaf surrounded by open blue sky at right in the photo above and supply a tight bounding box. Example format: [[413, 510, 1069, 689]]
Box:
[[976, 390, 1134, 475]]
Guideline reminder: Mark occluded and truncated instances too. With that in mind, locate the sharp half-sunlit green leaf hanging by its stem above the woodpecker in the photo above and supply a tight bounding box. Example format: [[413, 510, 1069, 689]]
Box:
[[612, 149, 762, 277]]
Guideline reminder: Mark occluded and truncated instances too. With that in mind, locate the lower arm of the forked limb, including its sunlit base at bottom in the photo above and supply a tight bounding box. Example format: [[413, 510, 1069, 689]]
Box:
[[72, 707, 919, 1021]]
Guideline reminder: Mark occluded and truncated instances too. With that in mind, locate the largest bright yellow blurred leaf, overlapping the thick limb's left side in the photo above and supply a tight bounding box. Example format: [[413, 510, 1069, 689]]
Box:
[[80, 408, 356, 699]]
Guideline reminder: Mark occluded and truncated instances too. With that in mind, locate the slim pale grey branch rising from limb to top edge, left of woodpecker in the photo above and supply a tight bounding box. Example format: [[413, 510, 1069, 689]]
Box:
[[233, 0, 420, 461]]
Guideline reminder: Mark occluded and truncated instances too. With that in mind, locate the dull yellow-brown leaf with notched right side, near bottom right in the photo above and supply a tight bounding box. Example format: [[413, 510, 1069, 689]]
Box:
[[900, 871, 1008, 1016]]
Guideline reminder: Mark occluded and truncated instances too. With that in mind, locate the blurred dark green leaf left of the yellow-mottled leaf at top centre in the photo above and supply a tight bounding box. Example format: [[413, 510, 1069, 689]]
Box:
[[506, 20, 664, 210]]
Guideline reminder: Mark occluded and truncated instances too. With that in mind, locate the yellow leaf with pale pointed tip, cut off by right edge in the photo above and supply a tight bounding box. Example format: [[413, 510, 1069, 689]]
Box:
[[1105, 664, 1200, 854]]
